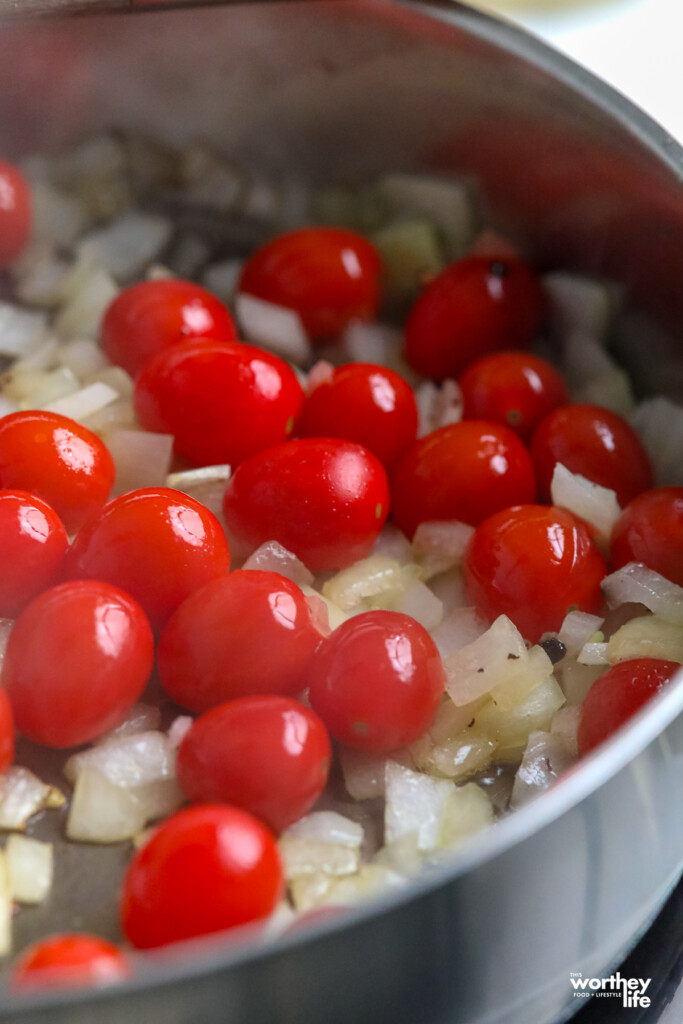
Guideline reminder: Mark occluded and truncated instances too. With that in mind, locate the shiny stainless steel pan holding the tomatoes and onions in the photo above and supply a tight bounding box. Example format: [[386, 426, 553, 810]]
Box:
[[0, 0, 683, 1024]]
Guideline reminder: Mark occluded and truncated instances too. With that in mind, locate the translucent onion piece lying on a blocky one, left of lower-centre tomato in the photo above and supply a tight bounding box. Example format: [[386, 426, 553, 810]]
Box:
[[63, 732, 175, 786]]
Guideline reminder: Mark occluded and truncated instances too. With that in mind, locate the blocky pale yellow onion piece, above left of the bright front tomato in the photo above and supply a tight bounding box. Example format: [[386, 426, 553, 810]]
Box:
[[67, 765, 146, 843]]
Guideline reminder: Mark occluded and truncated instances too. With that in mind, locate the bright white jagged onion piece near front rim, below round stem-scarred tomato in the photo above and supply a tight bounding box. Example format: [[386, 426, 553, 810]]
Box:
[[384, 761, 455, 850]]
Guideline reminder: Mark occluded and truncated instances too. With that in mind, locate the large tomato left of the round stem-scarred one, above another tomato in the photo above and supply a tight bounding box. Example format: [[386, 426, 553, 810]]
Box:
[[159, 569, 321, 711]]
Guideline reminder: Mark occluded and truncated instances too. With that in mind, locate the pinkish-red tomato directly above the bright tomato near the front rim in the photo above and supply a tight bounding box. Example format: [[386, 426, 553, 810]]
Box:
[[177, 696, 332, 833]]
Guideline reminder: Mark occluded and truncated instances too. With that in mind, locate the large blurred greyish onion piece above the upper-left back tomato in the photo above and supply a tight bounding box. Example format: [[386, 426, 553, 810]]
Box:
[[78, 210, 173, 281]]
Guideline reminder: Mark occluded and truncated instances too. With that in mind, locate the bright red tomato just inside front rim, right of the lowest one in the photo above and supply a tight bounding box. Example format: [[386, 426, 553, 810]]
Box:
[[121, 804, 284, 949]]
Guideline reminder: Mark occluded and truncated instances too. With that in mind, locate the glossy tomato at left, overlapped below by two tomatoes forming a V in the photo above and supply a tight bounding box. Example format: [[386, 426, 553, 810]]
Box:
[[65, 487, 230, 628]]
